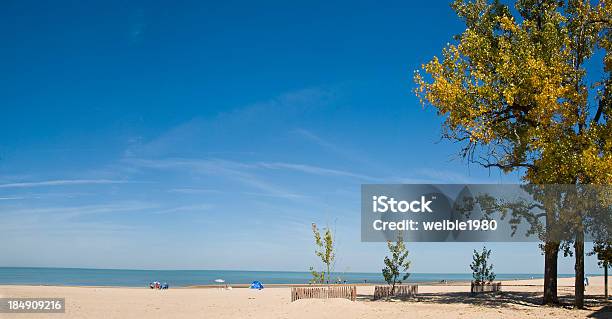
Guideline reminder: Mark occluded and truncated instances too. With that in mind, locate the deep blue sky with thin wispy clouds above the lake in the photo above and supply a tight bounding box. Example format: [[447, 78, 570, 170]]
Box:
[[0, 1, 599, 273]]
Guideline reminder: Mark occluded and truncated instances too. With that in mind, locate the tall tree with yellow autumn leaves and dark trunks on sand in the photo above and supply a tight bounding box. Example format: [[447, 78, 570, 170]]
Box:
[[415, 0, 612, 307]]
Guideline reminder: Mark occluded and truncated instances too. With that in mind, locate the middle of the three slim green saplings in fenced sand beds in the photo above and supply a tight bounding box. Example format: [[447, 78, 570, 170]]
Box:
[[382, 235, 410, 295]]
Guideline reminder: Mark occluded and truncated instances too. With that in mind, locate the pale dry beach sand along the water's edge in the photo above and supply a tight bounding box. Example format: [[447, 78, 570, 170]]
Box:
[[0, 277, 612, 319]]
